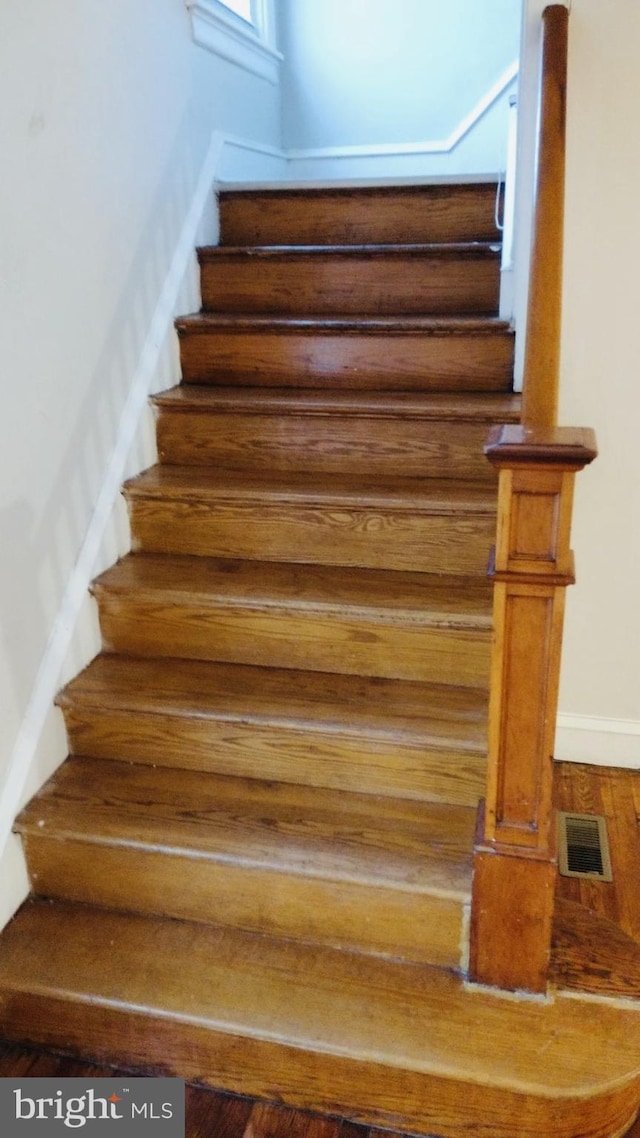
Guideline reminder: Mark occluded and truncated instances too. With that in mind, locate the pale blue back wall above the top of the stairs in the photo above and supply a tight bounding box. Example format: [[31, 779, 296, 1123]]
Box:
[[278, 0, 520, 176]]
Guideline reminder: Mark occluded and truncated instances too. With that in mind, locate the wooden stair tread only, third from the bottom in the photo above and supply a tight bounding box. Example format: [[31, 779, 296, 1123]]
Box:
[[58, 654, 486, 756]]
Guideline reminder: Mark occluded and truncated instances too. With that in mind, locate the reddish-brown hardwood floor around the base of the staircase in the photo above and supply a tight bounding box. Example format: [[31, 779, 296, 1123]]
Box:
[[0, 764, 640, 1138]]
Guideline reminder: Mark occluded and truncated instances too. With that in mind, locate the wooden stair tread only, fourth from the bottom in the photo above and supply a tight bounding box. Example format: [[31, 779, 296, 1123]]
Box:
[[92, 553, 492, 629]]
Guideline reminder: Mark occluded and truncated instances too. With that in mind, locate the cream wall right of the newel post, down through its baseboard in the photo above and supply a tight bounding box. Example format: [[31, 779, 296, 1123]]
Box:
[[548, 0, 640, 766]]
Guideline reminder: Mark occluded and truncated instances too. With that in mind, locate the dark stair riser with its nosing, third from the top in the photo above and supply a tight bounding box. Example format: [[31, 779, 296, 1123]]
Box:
[[175, 314, 514, 393]]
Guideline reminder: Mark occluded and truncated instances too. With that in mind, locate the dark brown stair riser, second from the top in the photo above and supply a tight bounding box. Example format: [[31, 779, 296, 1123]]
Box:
[[200, 254, 500, 316]]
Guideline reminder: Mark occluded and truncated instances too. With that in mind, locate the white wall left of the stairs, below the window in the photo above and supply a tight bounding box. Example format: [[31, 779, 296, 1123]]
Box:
[[0, 0, 281, 920]]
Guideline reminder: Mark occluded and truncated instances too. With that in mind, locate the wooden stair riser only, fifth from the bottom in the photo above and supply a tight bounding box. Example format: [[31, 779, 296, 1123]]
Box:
[[131, 497, 495, 575]]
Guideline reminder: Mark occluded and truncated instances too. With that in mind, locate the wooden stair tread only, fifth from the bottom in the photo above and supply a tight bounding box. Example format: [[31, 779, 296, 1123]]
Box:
[[125, 464, 497, 516]]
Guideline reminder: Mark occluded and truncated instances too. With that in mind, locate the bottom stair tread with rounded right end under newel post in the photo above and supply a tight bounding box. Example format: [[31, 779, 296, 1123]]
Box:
[[0, 901, 640, 1101]]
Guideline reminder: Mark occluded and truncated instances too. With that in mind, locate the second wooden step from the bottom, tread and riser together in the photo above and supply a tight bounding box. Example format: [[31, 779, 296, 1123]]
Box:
[[17, 759, 474, 967]]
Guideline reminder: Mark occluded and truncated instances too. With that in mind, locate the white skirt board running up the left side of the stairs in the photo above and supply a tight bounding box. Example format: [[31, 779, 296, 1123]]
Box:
[[0, 131, 224, 927]]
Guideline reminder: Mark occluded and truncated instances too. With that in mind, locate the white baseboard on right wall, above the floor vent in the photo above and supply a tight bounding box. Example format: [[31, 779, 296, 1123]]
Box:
[[555, 714, 640, 770]]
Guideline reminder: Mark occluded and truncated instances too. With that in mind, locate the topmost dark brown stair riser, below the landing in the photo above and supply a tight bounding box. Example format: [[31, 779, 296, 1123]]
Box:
[[220, 183, 500, 245]]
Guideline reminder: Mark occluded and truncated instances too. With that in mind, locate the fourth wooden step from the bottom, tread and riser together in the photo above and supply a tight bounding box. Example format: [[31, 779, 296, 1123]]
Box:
[[93, 554, 491, 687]]
